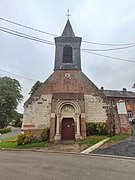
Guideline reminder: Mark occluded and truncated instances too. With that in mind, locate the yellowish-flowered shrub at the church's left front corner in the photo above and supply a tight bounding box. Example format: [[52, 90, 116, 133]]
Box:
[[17, 131, 33, 146]]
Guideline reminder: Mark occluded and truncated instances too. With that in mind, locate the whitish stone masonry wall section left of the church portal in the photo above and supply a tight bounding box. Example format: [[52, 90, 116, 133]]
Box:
[[22, 95, 52, 129]]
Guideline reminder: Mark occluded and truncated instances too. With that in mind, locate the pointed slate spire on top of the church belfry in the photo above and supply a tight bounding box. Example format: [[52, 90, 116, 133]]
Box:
[[62, 19, 75, 37]]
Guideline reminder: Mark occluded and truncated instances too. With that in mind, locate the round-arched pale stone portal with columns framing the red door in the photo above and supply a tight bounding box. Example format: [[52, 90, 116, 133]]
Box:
[[55, 101, 81, 140]]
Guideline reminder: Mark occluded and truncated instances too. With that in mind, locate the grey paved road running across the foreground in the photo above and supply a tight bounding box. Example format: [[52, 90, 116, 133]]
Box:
[[0, 151, 135, 180]]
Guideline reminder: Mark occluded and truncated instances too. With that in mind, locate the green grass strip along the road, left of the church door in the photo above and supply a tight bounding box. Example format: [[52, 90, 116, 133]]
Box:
[[0, 136, 49, 149]]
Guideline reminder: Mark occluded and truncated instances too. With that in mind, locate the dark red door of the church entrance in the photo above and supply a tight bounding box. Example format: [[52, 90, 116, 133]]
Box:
[[61, 118, 75, 140]]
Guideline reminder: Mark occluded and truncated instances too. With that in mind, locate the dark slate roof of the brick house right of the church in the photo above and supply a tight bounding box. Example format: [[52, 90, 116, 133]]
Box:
[[101, 90, 135, 98]]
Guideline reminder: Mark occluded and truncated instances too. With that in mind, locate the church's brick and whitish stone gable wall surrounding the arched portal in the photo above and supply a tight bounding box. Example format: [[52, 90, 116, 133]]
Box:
[[23, 70, 108, 141]]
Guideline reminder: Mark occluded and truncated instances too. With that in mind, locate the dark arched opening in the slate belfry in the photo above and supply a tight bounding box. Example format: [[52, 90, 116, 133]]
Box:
[[63, 45, 72, 63]]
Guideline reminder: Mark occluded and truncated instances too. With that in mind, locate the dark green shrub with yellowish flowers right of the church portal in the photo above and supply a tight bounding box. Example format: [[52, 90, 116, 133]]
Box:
[[86, 123, 107, 136]]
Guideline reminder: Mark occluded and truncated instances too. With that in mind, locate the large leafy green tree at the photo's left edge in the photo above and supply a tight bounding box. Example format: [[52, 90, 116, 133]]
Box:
[[0, 76, 23, 128]]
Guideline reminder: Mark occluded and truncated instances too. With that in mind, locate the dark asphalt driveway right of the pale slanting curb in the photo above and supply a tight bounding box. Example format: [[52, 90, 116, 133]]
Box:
[[92, 125, 135, 157]]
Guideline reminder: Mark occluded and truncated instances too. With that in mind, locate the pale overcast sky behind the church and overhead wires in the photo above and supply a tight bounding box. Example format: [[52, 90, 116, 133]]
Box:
[[0, 0, 135, 112]]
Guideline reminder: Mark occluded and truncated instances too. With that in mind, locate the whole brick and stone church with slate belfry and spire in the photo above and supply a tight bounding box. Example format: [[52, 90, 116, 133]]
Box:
[[22, 20, 132, 142]]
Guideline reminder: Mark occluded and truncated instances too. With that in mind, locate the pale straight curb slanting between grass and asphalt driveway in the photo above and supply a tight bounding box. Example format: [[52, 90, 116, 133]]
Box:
[[81, 138, 110, 154]]
